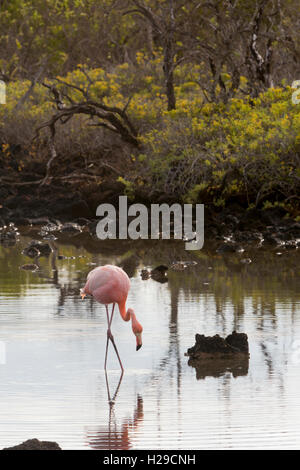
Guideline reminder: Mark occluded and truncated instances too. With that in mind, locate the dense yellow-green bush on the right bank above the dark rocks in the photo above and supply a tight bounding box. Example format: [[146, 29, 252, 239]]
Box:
[[141, 87, 300, 205]]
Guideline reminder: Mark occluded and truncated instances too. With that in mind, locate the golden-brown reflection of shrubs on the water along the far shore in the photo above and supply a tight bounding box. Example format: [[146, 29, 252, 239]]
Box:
[[0, 234, 300, 315]]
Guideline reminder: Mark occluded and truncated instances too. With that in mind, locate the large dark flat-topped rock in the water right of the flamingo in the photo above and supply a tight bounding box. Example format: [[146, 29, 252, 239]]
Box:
[[186, 331, 249, 359]]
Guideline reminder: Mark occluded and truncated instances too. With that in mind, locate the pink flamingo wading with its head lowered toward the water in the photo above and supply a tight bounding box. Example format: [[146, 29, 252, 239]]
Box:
[[80, 264, 143, 374]]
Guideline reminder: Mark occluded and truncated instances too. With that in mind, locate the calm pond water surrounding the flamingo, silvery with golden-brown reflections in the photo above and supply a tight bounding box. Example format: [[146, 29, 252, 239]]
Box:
[[0, 229, 300, 449]]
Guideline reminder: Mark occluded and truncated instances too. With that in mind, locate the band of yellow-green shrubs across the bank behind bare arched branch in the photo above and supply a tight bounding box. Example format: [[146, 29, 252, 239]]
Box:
[[0, 49, 300, 206]]
